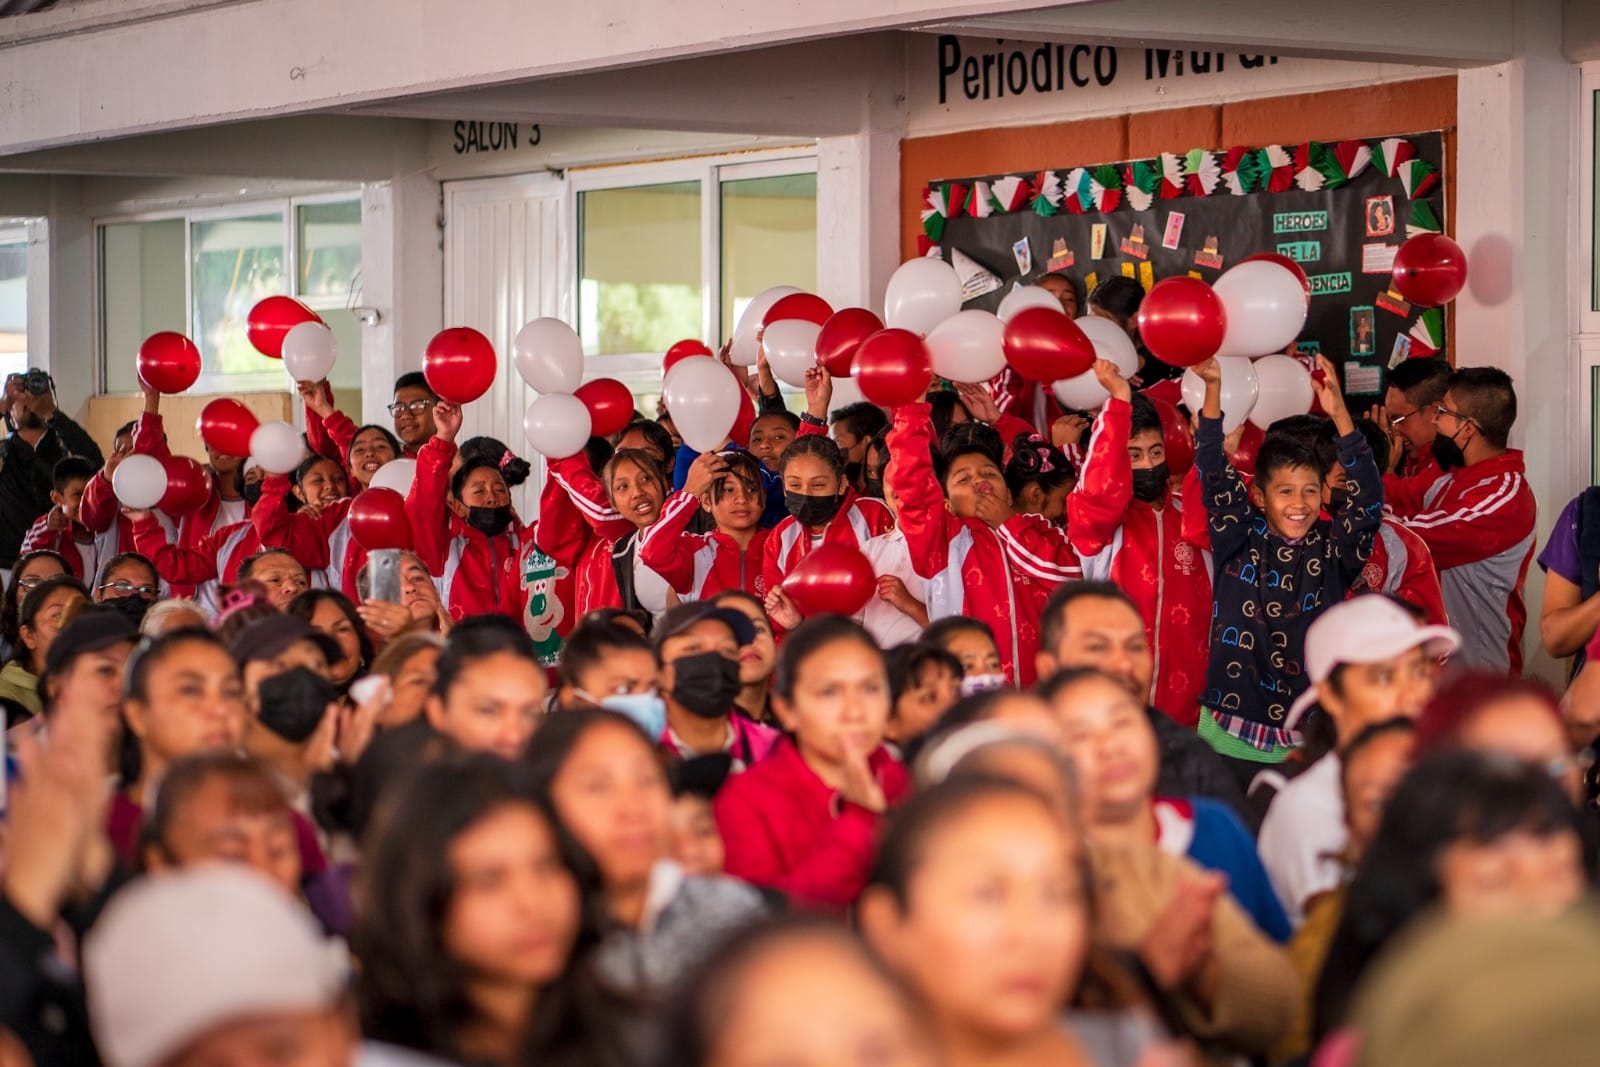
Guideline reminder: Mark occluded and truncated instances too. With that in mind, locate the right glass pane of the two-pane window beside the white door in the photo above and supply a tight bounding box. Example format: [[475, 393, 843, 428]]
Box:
[[729, 174, 816, 338]]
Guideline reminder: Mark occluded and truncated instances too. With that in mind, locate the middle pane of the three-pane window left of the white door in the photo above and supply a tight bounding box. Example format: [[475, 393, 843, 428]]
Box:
[[189, 211, 288, 374]]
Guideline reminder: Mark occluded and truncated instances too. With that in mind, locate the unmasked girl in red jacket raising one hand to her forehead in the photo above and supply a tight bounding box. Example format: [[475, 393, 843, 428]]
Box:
[[638, 450, 768, 600]]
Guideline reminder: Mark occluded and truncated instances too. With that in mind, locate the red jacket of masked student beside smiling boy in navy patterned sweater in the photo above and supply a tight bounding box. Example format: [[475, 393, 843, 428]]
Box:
[[1067, 398, 1211, 726]]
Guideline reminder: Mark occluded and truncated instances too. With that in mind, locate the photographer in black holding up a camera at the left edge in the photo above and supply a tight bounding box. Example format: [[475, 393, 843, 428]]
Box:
[[0, 370, 104, 571]]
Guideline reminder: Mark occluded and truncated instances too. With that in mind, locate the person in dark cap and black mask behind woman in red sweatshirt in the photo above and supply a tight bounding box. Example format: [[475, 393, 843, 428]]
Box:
[[651, 601, 778, 769]]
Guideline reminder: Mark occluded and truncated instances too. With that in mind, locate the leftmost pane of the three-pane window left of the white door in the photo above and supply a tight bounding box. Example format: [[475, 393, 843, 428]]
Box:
[[99, 219, 189, 392]]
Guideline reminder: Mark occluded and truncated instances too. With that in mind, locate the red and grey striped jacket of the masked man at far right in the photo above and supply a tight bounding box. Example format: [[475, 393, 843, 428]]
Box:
[[1384, 450, 1539, 677]]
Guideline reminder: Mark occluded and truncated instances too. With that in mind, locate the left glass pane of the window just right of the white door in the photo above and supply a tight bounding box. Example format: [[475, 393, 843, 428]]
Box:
[[578, 181, 704, 355]]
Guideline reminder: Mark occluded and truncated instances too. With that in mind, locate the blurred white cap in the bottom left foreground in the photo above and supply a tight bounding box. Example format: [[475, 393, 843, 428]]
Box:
[[83, 864, 349, 1067]]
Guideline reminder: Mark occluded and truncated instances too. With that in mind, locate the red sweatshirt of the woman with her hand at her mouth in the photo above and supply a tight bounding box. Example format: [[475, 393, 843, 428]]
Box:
[[714, 737, 910, 912]]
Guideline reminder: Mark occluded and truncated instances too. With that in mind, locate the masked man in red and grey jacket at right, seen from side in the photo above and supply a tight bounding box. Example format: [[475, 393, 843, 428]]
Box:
[[1384, 366, 1538, 678]]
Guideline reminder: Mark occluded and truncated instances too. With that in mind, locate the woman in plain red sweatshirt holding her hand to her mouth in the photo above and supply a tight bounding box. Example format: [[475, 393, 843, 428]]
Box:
[[715, 616, 909, 912]]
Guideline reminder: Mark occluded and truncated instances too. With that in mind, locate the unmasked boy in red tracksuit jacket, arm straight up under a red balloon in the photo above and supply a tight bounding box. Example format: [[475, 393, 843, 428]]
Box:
[[883, 403, 1083, 686]]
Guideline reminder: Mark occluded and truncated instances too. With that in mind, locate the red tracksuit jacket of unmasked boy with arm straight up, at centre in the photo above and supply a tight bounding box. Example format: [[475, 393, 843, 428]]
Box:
[[889, 403, 1083, 686]]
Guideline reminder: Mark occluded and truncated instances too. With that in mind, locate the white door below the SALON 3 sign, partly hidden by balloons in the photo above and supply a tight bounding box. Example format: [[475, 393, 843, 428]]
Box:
[[445, 174, 566, 522]]
